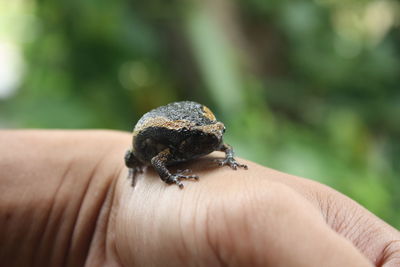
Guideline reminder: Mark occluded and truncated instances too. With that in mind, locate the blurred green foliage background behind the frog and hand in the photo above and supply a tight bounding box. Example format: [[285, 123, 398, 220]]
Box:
[[0, 0, 400, 228]]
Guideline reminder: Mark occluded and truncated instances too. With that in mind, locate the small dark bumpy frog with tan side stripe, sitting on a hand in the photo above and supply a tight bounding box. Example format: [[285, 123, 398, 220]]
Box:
[[125, 101, 247, 188]]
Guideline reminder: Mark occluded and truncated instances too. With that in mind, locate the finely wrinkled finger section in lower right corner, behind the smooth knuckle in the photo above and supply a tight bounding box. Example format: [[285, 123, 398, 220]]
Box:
[[312, 186, 400, 267]]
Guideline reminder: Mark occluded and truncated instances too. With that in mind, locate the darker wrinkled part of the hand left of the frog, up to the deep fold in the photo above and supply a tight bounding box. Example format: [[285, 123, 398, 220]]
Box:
[[0, 131, 128, 266]]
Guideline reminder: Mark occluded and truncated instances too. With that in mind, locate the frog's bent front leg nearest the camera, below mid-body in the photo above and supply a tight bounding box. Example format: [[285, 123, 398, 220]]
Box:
[[151, 148, 199, 189]]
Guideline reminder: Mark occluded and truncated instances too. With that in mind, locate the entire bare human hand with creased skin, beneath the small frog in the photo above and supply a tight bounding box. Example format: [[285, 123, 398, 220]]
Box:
[[0, 131, 400, 267]]
